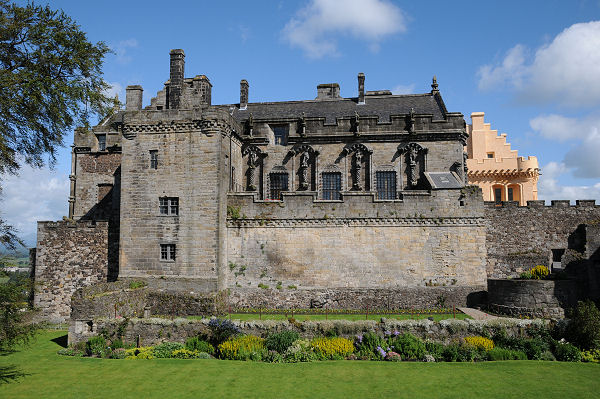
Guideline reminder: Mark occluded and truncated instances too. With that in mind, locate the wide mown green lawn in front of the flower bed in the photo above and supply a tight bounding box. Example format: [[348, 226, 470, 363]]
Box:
[[0, 331, 600, 399]]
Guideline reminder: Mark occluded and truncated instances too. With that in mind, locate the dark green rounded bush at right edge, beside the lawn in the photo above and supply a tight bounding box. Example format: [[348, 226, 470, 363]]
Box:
[[566, 299, 600, 349]]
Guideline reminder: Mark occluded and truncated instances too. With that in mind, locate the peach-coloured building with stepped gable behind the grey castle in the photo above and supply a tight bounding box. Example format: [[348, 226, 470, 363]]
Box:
[[466, 112, 540, 206]]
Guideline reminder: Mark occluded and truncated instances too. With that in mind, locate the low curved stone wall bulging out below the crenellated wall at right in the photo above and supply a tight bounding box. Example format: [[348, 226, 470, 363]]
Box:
[[488, 279, 577, 318]]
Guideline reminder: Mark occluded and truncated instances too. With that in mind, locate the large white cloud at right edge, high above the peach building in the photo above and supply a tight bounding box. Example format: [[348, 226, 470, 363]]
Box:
[[478, 21, 600, 107]]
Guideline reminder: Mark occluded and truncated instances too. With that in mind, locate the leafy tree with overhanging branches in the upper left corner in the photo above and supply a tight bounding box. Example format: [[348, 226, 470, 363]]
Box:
[[0, 0, 112, 248]]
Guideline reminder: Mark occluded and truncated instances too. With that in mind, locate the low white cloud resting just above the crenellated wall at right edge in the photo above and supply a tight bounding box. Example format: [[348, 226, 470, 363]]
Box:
[[538, 162, 600, 202]]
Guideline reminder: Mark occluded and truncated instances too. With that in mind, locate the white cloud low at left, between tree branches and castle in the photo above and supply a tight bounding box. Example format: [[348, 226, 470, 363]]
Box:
[[0, 165, 69, 246]]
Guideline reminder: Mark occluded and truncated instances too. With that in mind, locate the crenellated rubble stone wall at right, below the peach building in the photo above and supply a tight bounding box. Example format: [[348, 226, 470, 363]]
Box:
[[485, 200, 600, 278]]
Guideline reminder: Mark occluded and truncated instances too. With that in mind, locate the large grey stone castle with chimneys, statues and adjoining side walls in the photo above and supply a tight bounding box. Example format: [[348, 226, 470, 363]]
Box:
[[33, 50, 600, 321]]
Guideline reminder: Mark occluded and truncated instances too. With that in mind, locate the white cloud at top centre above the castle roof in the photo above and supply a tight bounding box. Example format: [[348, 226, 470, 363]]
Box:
[[283, 0, 406, 58]]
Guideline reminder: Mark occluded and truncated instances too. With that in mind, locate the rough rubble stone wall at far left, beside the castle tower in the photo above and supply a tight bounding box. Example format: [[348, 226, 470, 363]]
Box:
[[34, 222, 108, 323]]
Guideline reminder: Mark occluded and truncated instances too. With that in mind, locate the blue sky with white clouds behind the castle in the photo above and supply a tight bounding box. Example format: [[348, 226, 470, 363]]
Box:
[[0, 0, 600, 246]]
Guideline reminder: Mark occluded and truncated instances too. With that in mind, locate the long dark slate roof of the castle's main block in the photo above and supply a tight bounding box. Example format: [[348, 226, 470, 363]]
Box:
[[218, 93, 445, 124]]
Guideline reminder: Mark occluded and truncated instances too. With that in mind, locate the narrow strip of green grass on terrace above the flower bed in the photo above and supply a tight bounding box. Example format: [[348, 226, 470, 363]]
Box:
[[189, 312, 470, 321]]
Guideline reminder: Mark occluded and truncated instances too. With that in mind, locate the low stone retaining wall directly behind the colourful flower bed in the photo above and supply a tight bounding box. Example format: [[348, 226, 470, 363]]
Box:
[[69, 318, 546, 345]]
